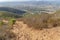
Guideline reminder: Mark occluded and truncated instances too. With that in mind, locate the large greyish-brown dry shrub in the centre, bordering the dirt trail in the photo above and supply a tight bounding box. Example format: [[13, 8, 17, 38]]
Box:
[[23, 13, 50, 29]]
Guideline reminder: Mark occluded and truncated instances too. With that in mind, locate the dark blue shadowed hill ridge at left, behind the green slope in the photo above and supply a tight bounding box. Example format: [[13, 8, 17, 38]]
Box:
[[0, 7, 26, 14]]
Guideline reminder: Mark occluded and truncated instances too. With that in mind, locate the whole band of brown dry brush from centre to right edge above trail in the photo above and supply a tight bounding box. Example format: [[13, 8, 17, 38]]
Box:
[[22, 11, 60, 29]]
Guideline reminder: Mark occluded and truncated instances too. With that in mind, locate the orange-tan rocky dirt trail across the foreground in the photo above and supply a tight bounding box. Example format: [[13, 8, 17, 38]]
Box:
[[12, 21, 60, 40]]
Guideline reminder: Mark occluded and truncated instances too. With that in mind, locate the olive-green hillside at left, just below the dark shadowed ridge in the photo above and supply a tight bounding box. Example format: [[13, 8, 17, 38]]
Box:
[[0, 11, 21, 18]]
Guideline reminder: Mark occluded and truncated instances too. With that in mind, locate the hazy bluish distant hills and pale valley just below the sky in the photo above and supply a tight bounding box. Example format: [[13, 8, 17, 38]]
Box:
[[0, 1, 60, 13]]
